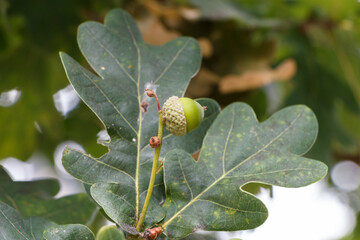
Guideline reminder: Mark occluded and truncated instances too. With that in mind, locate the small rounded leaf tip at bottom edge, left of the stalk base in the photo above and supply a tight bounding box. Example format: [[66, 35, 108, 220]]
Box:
[[44, 224, 95, 240]]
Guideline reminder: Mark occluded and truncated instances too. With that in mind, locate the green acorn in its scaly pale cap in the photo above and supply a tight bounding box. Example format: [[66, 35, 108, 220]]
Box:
[[161, 96, 204, 136]]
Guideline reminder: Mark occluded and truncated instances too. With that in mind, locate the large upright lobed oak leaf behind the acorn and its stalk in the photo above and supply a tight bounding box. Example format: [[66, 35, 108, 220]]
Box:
[[61, 9, 219, 229]]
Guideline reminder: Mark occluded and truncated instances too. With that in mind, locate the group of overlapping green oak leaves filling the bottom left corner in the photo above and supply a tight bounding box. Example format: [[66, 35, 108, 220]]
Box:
[[0, 167, 97, 240]]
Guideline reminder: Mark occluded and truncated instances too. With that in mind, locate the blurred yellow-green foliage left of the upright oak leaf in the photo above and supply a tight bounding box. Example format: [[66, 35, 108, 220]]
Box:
[[0, 0, 125, 161]]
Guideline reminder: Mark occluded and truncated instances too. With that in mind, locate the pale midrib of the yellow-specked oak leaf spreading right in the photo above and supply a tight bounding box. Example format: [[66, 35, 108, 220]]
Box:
[[162, 111, 303, 228]]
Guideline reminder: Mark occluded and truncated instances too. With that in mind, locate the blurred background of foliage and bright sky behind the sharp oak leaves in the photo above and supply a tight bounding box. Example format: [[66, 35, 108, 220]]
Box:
[[0, 0, 360, 240]]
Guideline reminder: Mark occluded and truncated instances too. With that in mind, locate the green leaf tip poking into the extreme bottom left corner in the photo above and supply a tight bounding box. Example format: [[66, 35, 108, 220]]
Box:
[[0, 201, 56, 240]]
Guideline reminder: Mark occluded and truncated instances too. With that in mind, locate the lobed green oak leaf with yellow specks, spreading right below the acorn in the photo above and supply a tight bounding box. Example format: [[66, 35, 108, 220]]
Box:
[[162, 103, 327, 238]]
